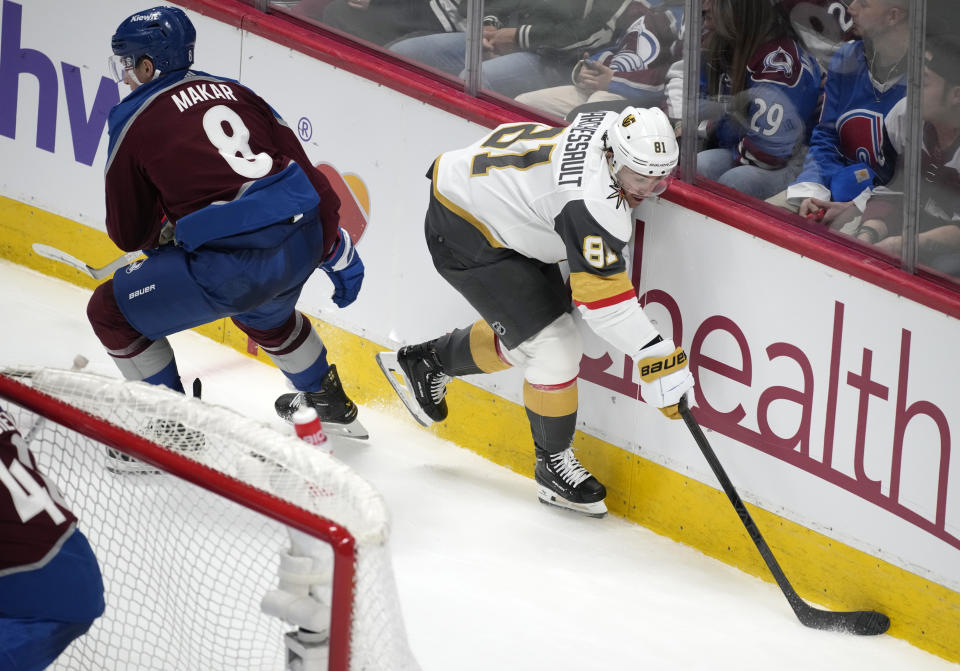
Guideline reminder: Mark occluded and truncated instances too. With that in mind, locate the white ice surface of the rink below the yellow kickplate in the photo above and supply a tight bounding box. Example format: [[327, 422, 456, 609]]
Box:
[[0, 260, 958, 671]]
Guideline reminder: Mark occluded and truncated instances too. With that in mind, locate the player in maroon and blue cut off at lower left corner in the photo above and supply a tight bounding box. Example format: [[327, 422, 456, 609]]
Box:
[[0, 408, 104, 671]]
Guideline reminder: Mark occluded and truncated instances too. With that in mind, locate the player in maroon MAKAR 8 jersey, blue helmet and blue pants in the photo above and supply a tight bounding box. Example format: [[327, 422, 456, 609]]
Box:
[[87, 7, 367, 446]]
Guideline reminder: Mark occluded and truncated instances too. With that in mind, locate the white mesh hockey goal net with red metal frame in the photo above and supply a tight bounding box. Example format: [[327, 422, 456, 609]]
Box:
[[0, 368, 419, 671]]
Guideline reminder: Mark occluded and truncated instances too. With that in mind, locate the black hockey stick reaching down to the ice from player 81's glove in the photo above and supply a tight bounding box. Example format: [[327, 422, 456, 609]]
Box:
[[680, 396, 890, 636]]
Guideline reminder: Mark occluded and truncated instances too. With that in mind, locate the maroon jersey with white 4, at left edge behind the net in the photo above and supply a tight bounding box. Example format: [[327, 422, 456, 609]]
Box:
[[0, 410, 77, 577]]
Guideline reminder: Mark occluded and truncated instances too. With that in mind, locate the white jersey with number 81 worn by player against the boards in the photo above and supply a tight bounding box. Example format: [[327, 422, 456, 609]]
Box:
[[433, 112, 658, 355]]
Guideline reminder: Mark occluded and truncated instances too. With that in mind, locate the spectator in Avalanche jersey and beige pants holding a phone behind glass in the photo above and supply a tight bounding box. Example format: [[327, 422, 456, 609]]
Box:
[[517, 1, 680, 118]]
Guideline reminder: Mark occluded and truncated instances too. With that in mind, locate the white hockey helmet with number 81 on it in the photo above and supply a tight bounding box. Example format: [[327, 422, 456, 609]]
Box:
[[607, 107, 680, 177]]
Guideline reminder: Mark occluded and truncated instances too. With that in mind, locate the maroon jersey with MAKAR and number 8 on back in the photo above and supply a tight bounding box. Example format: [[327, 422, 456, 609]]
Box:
[[105, 70, 337, 255]]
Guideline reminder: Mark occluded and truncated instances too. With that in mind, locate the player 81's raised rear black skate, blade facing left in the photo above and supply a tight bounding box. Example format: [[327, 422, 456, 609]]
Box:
[[377, 342, 453, 426]]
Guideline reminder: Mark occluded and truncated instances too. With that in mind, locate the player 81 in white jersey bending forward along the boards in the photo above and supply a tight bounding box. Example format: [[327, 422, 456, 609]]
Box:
[[378, 107, 693, 517]]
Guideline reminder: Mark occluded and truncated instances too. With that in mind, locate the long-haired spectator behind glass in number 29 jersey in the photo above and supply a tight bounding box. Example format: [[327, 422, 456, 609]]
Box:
[[697, 0, 821, 199]]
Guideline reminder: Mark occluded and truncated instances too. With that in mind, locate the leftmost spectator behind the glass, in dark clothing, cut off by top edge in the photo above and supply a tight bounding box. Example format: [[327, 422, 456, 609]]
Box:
[[295, 0, 466, 45]]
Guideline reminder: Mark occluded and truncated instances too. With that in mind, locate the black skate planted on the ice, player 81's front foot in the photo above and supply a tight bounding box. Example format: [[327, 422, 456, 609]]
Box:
[[534, 447, 607, 517]]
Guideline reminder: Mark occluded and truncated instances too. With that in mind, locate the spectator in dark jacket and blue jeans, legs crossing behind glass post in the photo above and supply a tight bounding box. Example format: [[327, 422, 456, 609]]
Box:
[[390, 0, 625, 98]]
